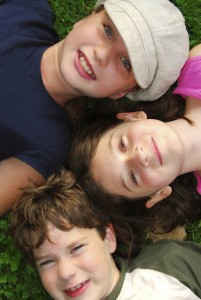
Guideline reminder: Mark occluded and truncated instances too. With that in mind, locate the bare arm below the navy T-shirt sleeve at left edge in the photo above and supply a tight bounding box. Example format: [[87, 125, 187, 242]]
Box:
[[0, 158, 45, 216]]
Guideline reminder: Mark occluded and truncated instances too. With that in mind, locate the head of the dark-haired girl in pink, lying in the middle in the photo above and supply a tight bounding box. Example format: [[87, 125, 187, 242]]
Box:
[[71, 98, 187, 207]]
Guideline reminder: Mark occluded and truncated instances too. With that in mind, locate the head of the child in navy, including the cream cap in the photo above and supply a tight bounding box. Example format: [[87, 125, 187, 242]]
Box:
[[59, 0, 189, 100]]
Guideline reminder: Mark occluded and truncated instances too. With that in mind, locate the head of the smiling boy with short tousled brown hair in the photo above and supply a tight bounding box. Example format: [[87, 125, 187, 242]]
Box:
[[10, 171, 119, 300]]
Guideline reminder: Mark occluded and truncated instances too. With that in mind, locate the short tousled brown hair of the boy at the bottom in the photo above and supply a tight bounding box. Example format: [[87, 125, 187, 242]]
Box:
[[10, 170, 141, 265]]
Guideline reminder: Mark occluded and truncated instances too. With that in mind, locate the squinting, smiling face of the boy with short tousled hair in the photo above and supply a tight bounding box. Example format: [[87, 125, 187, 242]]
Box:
[[34, 224, 119, 300]]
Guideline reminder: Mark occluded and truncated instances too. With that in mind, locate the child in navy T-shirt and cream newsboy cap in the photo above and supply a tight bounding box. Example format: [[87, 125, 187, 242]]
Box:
[[0, 0, 189, 215]]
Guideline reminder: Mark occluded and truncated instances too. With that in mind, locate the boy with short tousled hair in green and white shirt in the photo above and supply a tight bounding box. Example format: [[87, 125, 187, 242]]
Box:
[[10, 172, 201, 300]]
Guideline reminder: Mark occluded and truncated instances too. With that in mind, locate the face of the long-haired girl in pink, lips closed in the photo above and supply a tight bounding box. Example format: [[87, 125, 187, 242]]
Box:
[[91, 119, 183, 198]]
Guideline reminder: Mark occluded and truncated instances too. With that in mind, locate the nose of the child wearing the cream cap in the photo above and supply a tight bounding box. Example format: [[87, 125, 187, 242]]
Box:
[[93, 43, 114, 67]]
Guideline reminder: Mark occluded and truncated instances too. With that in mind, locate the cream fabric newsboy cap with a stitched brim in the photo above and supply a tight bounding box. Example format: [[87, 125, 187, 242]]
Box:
[[95, 0, 189, 101]]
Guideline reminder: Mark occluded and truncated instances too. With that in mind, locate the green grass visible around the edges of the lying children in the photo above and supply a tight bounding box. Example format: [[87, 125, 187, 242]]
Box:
[[0, 0, 201, 300]]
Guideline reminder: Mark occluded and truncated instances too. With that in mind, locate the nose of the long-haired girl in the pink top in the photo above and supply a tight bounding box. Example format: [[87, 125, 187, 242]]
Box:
[[128, 146, 149, 168]]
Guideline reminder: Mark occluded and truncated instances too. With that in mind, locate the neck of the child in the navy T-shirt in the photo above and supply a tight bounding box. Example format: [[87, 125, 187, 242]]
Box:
[[41, 41, 80, 107]]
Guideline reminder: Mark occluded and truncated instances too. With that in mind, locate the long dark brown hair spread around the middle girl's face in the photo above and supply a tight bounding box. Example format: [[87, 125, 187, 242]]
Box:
[[70, 93, 201, 232]]
